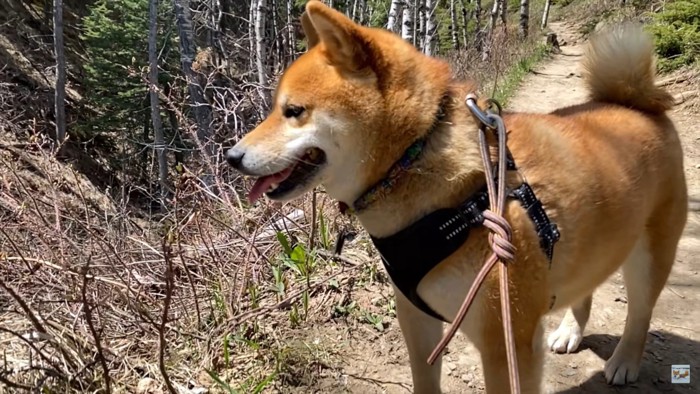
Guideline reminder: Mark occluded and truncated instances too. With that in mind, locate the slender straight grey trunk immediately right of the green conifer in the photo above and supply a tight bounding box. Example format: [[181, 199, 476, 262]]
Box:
[[148, 0, 168, 198]]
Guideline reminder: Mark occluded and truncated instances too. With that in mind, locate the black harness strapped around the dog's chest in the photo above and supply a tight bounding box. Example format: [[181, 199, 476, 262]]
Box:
[[371, 149, 559, 322]]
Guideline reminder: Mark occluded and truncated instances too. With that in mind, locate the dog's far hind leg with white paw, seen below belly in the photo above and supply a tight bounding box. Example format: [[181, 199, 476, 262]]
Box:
[[547, 295, 593, 353]]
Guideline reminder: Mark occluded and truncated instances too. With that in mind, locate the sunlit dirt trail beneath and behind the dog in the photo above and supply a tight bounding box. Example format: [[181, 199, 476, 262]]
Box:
[[305, 23, 700, 393]]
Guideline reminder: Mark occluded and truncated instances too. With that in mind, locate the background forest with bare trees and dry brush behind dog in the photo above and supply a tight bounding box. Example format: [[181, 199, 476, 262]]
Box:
[[0, 0, 700, 393]]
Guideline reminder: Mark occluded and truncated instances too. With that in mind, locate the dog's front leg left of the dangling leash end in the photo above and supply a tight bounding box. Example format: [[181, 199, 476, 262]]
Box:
[[394, 287, 442, 394]]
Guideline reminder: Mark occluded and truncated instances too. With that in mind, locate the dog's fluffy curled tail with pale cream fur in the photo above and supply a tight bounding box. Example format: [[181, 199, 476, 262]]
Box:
[[583, 23, 674, 114]]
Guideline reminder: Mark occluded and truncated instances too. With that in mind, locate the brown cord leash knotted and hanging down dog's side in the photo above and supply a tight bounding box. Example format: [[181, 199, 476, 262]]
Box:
[[428, 94, 520, 394]]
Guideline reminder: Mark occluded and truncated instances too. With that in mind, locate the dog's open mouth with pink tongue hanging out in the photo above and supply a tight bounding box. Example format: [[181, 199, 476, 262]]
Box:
[[248, 148, 326, 203]]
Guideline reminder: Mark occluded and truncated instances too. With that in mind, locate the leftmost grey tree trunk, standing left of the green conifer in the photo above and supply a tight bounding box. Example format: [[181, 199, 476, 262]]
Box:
[[53, 0, 66, 146]]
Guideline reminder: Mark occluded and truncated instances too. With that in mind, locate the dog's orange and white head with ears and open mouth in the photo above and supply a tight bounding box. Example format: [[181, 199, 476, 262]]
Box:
[[226, 1, 449, 202]]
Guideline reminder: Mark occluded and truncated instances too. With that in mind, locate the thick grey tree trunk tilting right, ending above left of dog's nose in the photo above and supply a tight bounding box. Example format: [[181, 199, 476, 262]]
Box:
[[174, 0, 213, 159]]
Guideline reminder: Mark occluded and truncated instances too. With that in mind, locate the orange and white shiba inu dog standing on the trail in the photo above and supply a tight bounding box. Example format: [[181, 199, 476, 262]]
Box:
[[226, 1, 688, 394]]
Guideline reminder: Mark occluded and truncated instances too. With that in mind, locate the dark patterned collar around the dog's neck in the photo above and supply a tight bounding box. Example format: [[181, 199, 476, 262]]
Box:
[[338, 95, 449, 214]]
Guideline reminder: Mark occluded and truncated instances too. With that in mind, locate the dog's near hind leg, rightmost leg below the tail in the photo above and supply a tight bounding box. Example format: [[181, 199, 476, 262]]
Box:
[[605, 219, 682, 385]]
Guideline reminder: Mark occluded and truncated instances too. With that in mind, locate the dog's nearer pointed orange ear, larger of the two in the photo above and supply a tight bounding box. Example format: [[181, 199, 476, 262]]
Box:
[[302, 0, 369, 71]]
